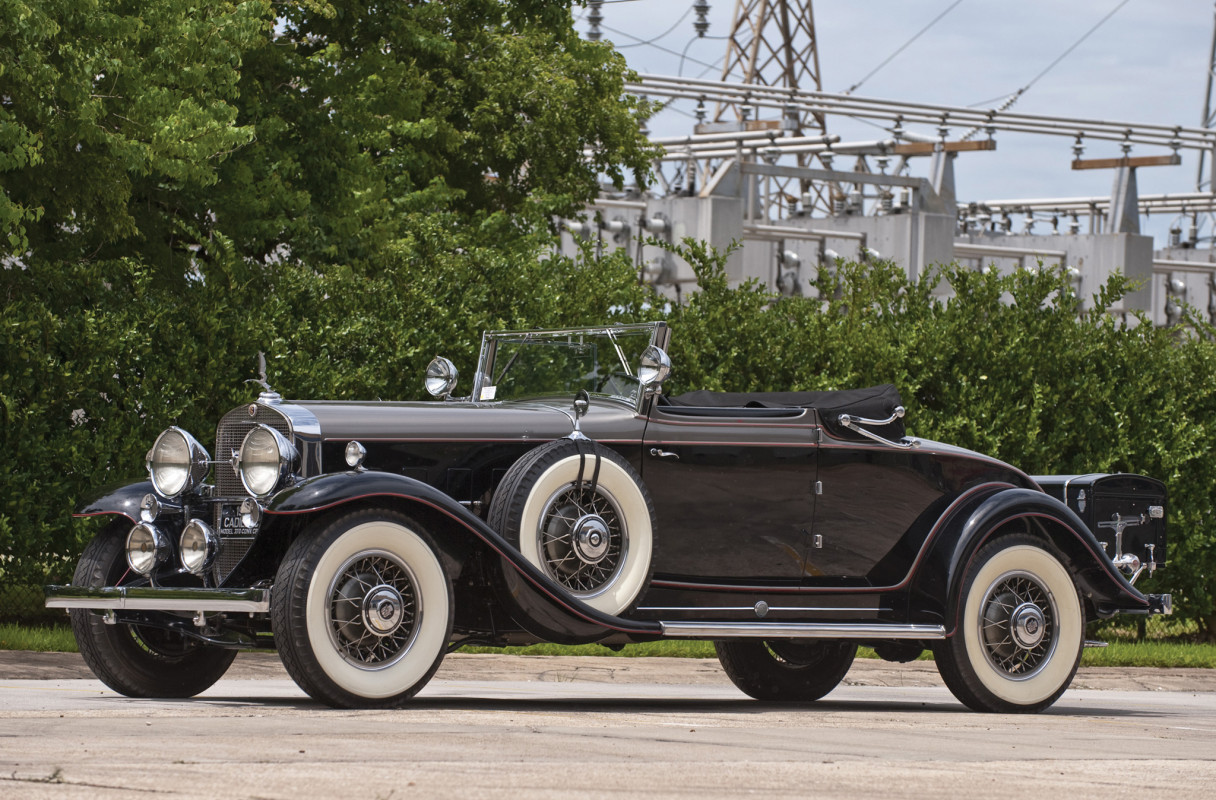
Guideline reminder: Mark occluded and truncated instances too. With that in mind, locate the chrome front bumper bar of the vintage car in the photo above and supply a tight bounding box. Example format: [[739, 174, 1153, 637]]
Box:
[[44, 586, 270, 614]]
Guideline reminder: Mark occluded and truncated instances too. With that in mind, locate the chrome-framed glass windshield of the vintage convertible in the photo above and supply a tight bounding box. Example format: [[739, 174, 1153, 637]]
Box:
[[473, 323, 663, 407]]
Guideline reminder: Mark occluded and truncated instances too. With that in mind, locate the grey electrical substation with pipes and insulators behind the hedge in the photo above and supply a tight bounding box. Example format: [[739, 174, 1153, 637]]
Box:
[[562, 0, 1216, 326]]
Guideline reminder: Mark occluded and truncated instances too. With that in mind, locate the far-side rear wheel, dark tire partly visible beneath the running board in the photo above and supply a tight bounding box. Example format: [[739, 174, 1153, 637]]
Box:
[[714, 640, 857, 700]]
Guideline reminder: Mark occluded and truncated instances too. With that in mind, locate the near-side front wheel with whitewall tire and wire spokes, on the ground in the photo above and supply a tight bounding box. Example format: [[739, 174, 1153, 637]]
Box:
[[270, 509, 452, 708]]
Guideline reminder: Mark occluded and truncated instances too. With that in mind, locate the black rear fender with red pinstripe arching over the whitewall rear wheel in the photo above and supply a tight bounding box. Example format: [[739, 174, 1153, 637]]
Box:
[[918, 488, 1149, 632]]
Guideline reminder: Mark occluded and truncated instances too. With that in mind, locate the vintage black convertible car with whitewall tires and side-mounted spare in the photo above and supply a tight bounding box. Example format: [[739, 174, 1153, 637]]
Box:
[[46, 322, 1170, 711]]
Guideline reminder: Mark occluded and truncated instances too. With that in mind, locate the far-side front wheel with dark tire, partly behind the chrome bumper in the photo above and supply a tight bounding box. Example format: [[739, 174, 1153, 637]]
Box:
[[71, 522, 236, 698]]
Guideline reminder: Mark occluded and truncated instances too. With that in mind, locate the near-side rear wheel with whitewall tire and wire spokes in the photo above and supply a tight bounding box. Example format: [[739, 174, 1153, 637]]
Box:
[[934, 535, 1085, 712]]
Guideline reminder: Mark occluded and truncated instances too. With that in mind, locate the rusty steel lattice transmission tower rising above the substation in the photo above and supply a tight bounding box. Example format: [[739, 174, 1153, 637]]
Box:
[[714, 0, 826, 135]]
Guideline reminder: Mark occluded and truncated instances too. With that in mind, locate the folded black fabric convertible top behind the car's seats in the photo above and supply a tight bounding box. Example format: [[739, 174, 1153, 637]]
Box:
[[664, 383, 903, 441]]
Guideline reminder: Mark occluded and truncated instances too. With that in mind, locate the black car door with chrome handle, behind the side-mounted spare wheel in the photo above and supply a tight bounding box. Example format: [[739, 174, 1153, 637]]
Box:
[[642, 405, 817, 584]]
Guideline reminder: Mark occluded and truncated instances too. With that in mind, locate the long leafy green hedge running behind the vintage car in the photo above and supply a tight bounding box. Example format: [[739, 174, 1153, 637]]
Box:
[[0, 237, 1216, 636]]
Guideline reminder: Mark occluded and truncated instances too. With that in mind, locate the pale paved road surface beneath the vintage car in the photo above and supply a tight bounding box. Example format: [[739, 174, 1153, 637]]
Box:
[[0, 654, 1216, 800]]
